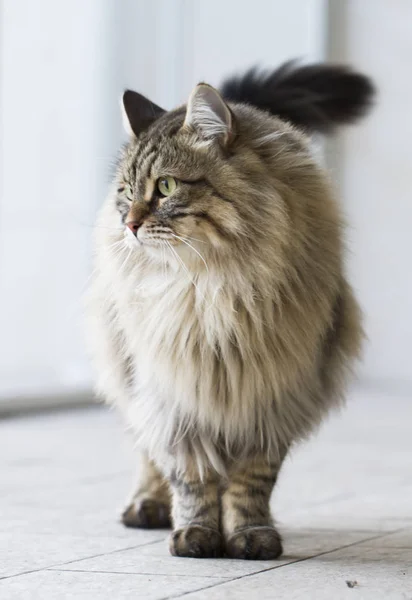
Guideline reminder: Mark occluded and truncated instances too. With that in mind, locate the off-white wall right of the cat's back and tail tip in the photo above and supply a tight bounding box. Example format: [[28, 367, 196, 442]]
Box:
[[331, 0, 412, 390]]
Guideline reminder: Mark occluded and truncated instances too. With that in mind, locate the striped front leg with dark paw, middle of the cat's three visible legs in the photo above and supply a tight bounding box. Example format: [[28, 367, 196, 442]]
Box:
[[170, 469, 222, 558]]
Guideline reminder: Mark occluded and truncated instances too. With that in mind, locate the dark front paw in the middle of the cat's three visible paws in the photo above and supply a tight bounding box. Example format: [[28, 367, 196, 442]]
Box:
[[169, 525, 222, 558]]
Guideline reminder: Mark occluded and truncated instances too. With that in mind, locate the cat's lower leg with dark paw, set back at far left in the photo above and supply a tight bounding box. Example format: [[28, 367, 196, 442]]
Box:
[[122, 454, 171, 529]]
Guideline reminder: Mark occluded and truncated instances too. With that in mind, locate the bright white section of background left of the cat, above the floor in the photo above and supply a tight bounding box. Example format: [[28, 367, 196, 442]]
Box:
[[0, 0, 112, 404]]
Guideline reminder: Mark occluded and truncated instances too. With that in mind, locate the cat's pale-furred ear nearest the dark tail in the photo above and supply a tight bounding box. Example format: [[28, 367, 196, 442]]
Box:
[[184, 83, 233, 144]]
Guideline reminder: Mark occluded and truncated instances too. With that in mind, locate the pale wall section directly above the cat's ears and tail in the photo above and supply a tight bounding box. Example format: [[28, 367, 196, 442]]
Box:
[[107, 0, 327, 135]]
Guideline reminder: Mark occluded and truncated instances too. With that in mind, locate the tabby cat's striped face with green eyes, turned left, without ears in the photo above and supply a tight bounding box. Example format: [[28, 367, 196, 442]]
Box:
[[116, 111, 241, 254]]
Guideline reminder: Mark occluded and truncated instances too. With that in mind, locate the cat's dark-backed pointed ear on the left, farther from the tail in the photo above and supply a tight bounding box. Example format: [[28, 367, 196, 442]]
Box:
[[121, 90, 165, 137]]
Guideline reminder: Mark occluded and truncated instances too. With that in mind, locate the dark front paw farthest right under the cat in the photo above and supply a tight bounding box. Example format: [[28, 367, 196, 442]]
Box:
[[226, 527, 282, 560]]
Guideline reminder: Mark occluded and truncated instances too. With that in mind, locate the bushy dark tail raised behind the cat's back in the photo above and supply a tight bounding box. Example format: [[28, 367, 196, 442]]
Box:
[[220, 61, 375, 134]]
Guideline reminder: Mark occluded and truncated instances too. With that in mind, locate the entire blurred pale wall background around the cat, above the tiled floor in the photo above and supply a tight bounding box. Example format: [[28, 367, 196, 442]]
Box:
[[0, 0, 412, 414]]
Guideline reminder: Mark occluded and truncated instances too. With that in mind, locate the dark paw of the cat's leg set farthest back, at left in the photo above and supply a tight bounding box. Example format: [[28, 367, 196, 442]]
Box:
[[122, 498, 172, 529]]
